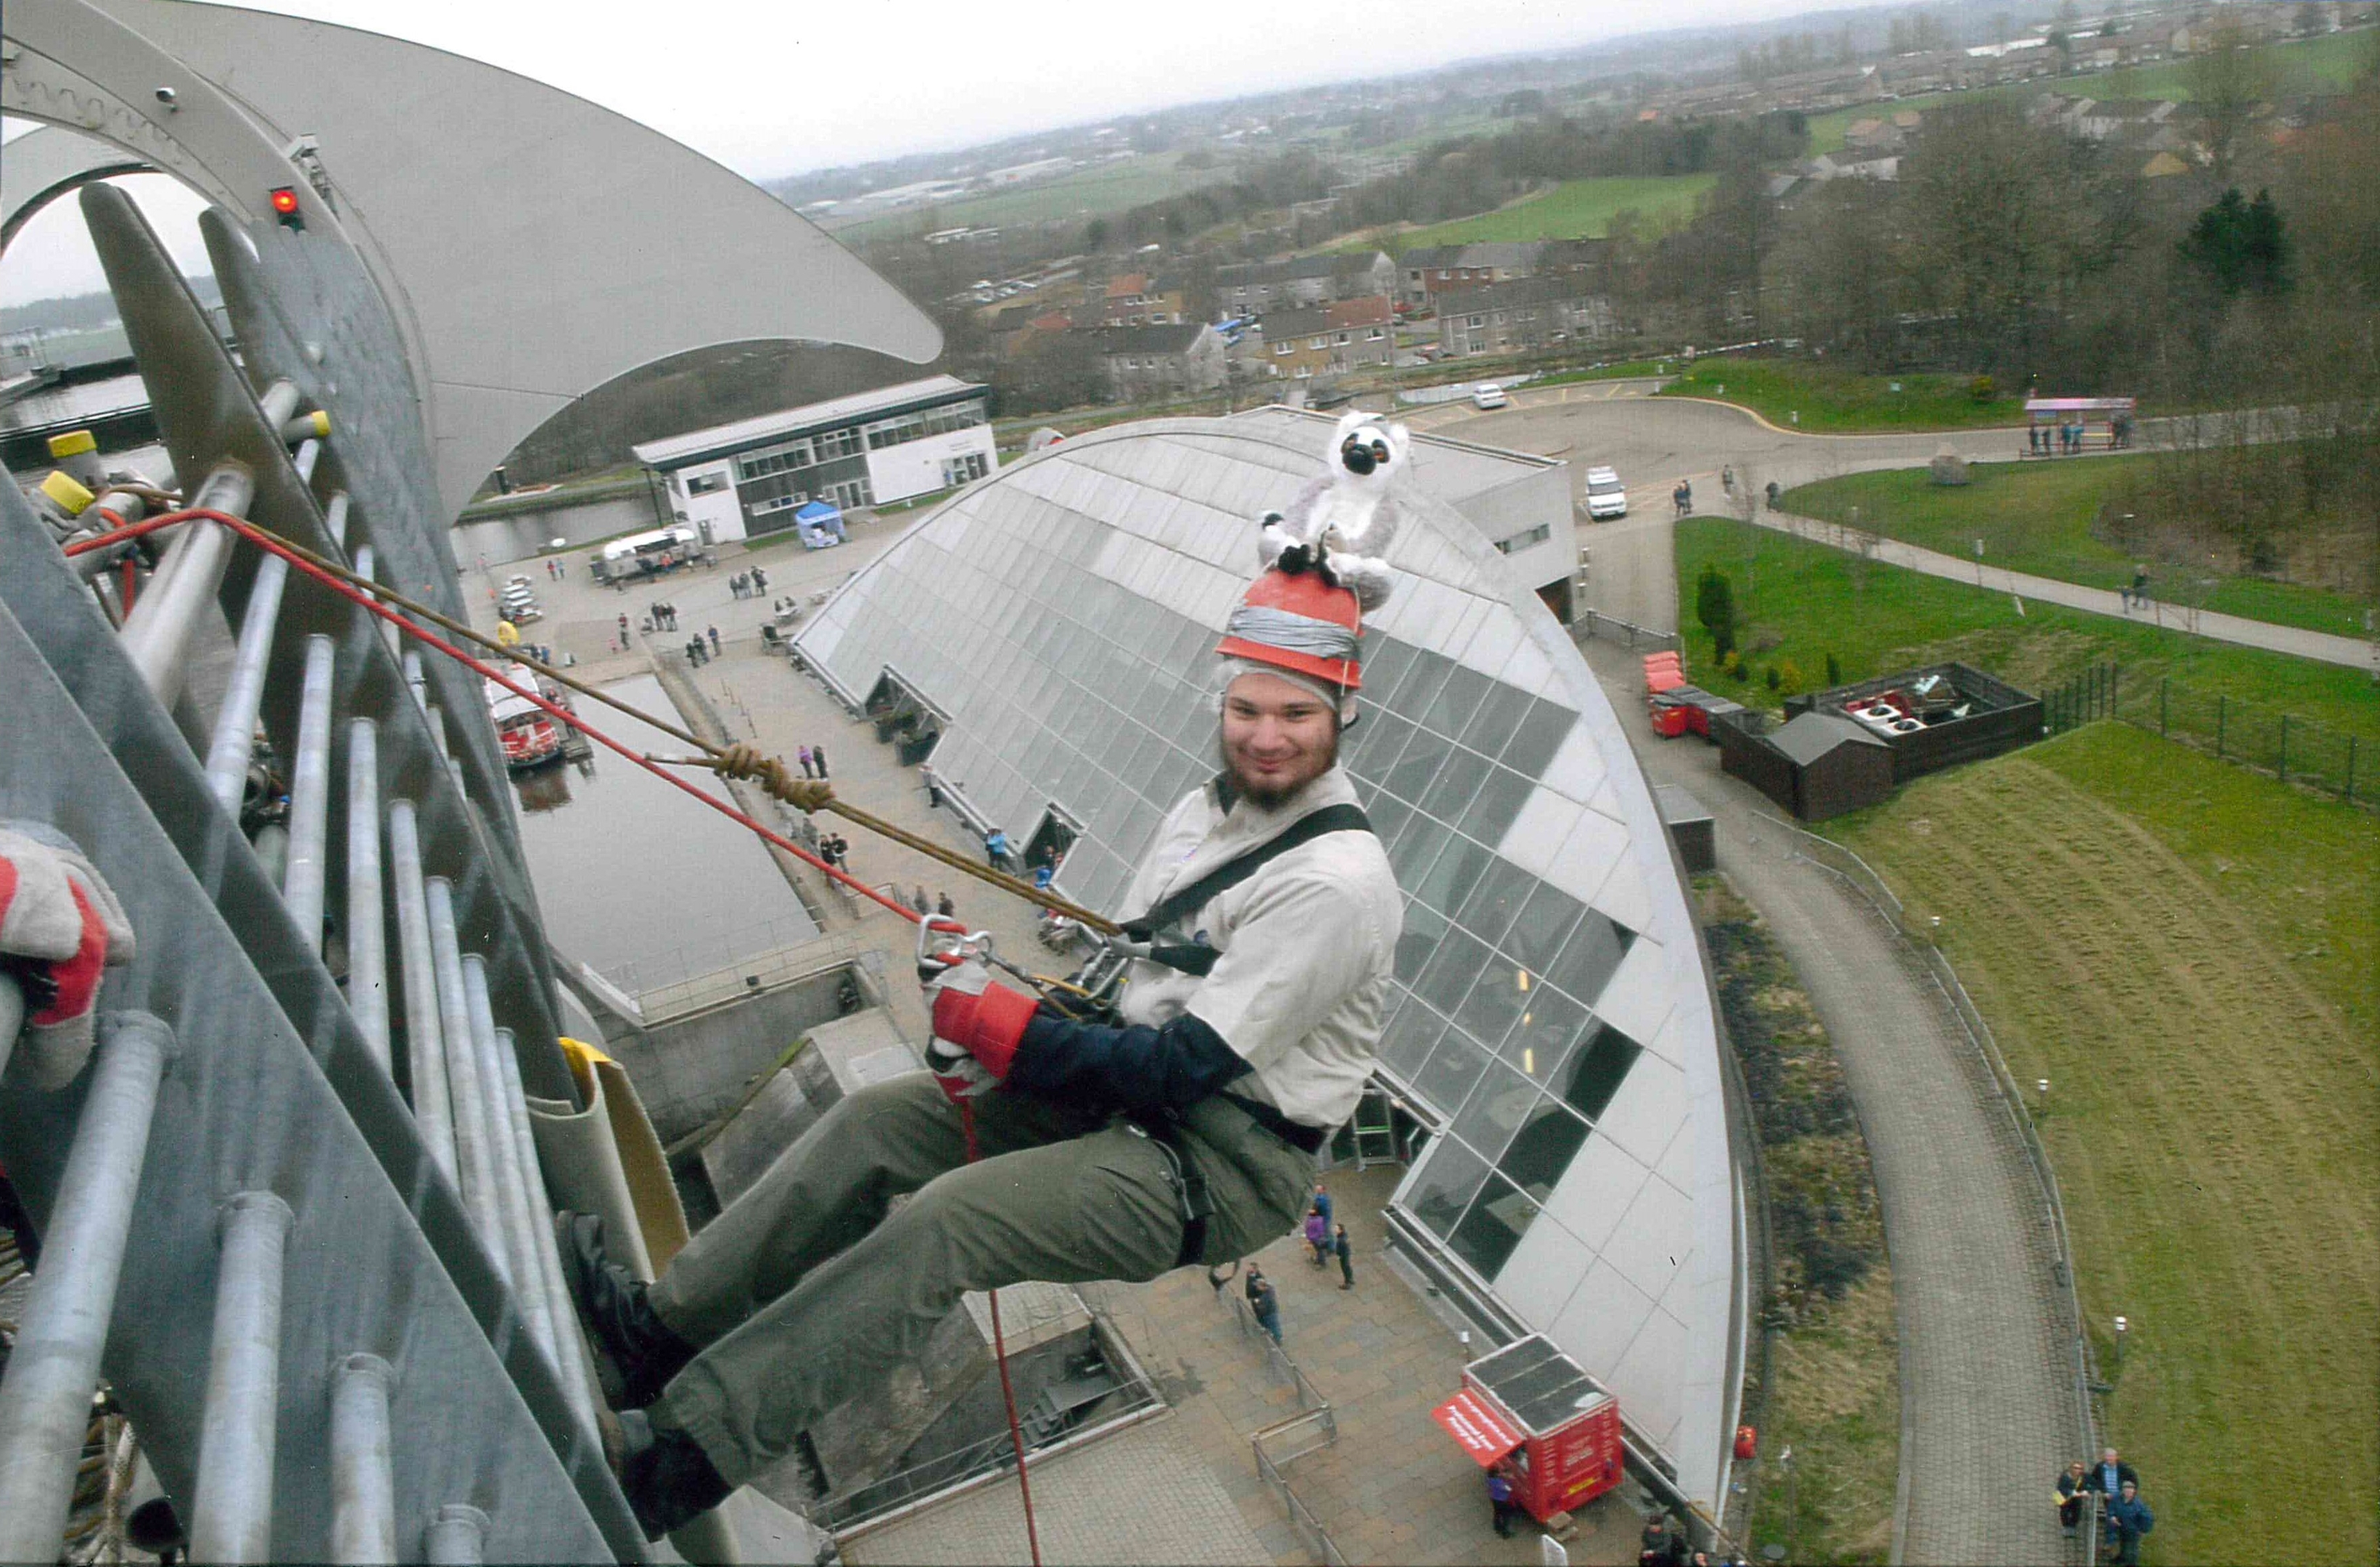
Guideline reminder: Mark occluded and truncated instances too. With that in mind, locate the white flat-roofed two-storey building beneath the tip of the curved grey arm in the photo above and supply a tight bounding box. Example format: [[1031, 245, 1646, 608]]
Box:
[[633, 377, 1000, 543]]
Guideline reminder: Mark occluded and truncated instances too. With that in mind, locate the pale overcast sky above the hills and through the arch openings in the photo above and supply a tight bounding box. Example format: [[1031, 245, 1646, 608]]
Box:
[[0, 0, 1856, 300]]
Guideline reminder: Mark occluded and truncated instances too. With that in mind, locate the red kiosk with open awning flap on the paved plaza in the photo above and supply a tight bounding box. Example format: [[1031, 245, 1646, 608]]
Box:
[[1430, 1333, 1621, 1524]]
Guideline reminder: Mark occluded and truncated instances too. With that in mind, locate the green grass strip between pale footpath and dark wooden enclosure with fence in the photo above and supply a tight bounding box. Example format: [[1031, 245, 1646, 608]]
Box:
[[1678, 517, 2380, 743]]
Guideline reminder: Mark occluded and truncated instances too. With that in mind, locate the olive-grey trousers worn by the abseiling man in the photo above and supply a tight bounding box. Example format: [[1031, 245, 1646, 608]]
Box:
[[650, 1072, 1314, 1484]]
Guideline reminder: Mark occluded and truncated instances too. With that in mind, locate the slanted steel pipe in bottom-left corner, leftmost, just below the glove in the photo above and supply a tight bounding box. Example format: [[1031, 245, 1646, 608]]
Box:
[[0, 1012, 174, 1562]]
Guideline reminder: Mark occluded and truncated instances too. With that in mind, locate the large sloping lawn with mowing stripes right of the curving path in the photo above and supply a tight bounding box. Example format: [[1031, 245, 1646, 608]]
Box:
[[1832, 724, 2380, 1565]]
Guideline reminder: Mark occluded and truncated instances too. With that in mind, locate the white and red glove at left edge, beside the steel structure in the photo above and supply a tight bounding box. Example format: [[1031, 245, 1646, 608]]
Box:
[[0, 822, 133, 1093]]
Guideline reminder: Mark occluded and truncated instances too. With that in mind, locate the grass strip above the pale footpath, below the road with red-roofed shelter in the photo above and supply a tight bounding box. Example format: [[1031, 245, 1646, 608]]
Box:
[[1782, 455, 2365, 636]]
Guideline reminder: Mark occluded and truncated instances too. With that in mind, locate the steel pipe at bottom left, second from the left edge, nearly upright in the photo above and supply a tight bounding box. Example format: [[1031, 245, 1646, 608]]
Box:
[[190, 1190, 290, 1562]]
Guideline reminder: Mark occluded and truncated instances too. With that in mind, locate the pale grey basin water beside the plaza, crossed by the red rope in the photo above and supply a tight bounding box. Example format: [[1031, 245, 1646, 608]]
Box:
[[514, 674, 819, 993]]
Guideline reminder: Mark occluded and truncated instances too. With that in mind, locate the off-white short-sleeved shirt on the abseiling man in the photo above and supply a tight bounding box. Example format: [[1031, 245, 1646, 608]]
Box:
[[1119, 767, 1404, 1129]]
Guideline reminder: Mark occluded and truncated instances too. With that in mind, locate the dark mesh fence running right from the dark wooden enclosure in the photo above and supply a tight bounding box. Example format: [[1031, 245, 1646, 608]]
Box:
[[2042, 665, 2373, 805]]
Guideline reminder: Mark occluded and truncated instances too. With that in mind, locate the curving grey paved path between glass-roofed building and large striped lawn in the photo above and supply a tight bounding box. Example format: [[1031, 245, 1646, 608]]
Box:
[[1585, 643, 2080, 1565]]
